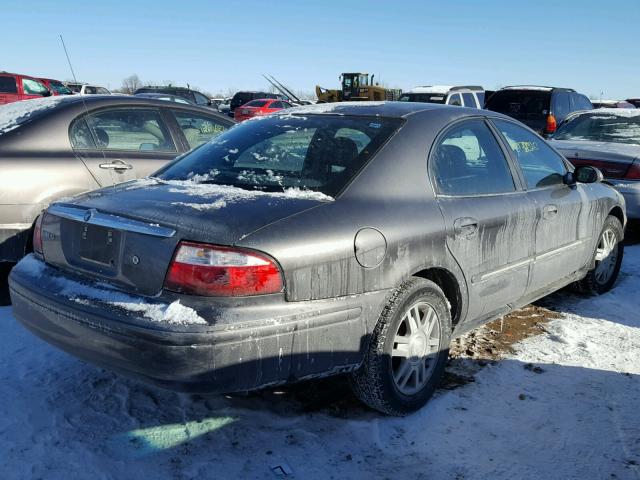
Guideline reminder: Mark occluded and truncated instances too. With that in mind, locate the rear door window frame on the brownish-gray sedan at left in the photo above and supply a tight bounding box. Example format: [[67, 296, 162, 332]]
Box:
[[67, 105, 179, 154]]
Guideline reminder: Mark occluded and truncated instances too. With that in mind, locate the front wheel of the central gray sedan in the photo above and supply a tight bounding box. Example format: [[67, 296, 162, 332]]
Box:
[[577, 215, 624, 295]]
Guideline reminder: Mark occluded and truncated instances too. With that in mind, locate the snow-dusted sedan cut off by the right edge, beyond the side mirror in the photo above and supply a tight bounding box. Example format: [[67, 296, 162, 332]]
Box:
[[550, 108, 640, 220]]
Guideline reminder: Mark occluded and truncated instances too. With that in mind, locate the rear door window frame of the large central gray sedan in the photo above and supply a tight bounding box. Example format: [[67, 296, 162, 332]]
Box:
[[427, 115, 526, 199]]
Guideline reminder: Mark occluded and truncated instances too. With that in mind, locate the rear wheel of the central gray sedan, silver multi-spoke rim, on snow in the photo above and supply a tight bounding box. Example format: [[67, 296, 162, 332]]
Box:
[[351, 278, 451, 415]]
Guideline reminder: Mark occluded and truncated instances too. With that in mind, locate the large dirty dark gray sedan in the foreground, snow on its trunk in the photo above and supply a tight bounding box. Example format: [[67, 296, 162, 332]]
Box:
[[10, 102, 626, 415]]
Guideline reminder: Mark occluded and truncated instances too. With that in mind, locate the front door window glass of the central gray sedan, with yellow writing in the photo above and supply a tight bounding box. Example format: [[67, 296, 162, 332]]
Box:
[[493, 120, 567, 188]]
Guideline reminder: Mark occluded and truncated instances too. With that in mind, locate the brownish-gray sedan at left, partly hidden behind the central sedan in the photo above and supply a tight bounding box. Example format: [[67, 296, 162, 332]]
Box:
[[0, 95, 234, 272]]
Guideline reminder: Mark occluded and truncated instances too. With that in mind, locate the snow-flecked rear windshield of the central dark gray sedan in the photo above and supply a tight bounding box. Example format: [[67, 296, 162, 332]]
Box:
[[157, 114, 402, 196]]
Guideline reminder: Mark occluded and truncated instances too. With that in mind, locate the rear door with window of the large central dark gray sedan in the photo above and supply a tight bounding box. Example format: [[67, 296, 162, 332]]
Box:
[[429, 118, 535, 322]]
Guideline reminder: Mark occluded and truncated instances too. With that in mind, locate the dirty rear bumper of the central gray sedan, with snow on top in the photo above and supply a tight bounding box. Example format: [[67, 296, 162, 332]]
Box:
[[10, 257, 386, 392]]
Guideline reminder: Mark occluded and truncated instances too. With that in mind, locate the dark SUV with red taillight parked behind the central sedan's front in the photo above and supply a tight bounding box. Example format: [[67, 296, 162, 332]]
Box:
[[485, 86, 593, 135]]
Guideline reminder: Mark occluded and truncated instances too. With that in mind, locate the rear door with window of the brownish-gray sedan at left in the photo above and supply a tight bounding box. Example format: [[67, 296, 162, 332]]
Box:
[[69, 107, 178, 186]]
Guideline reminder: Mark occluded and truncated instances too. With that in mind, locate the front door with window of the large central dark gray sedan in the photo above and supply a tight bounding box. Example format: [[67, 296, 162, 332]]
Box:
[[492, 120, 602, 293]]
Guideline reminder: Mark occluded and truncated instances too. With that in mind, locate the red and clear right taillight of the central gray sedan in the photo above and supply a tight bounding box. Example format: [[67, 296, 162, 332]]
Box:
[[164, 242, 282, 297]]
